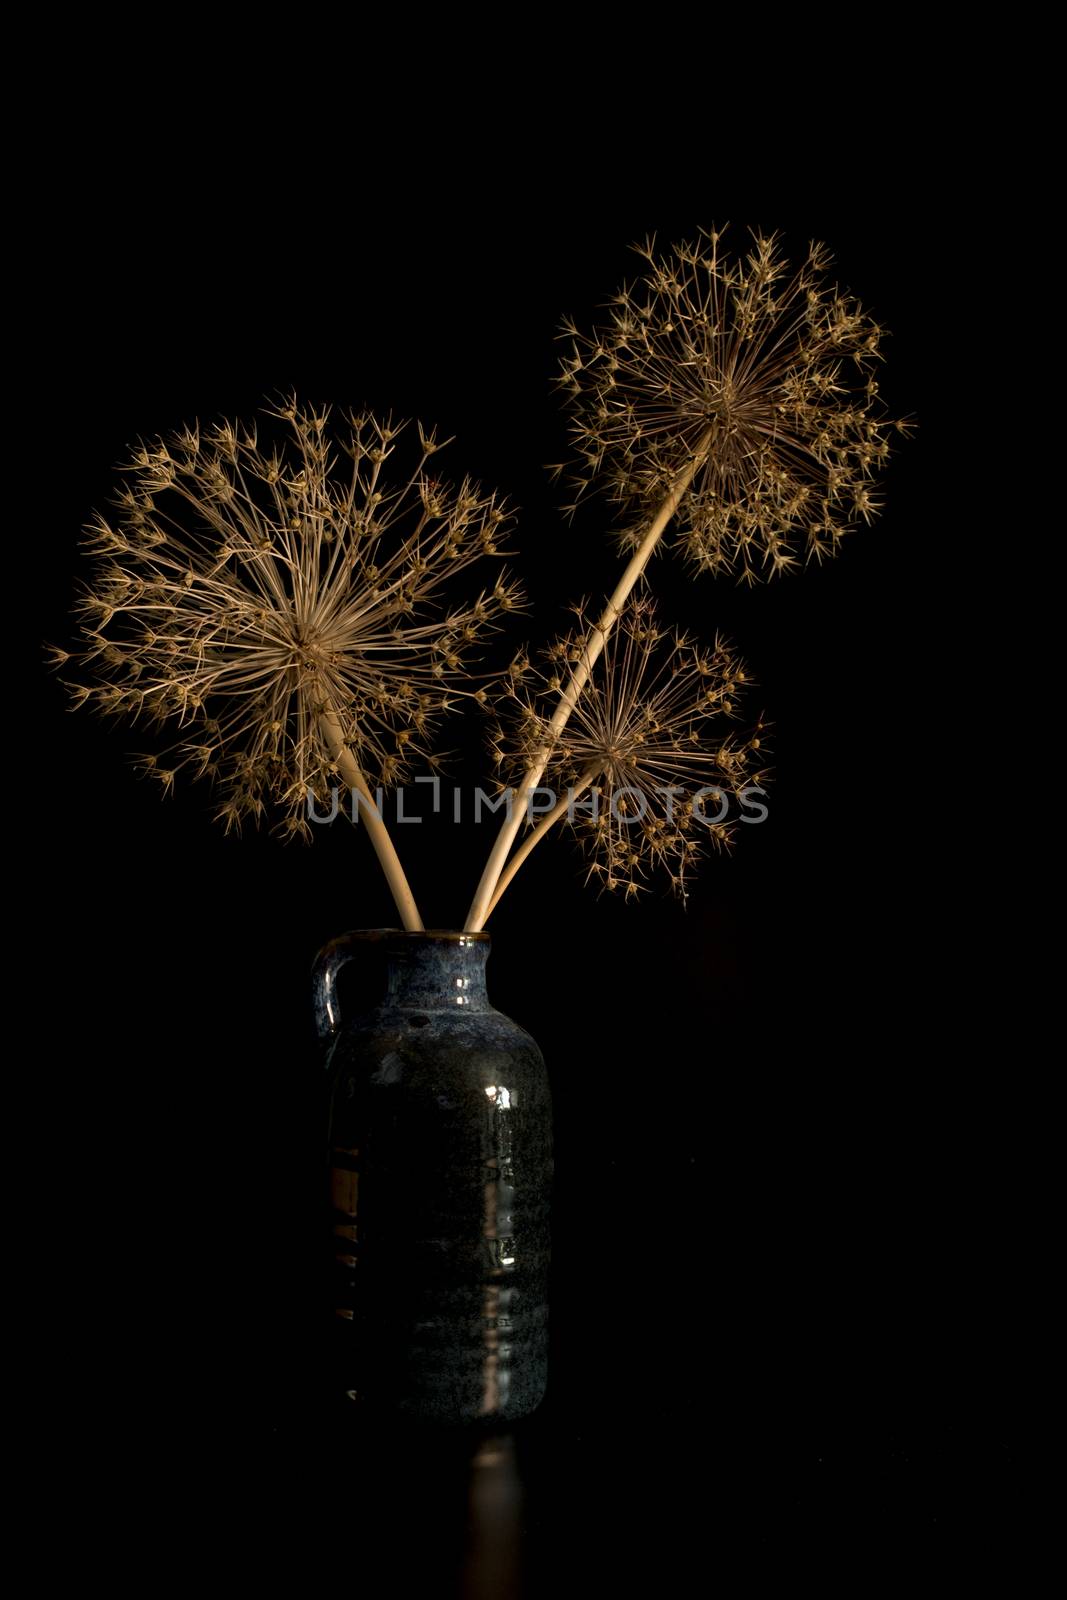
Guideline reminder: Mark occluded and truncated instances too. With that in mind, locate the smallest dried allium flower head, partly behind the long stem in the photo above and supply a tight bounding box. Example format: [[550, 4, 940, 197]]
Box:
[[493, 598, 766, 898]]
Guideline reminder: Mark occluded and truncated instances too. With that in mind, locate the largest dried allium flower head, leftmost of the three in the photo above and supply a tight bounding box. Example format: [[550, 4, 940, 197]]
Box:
[[64, 400, 518, 837]]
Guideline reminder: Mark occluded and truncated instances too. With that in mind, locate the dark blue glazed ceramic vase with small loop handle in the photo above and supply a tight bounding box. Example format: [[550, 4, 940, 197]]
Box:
[[314, 930, 552, 1424]]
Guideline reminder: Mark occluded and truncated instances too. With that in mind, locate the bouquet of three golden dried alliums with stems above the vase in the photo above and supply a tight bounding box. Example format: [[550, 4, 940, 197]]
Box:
[[54, 229, 907, 931]]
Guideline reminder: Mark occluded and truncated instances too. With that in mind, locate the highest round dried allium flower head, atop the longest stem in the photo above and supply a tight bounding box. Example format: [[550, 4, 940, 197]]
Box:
[[555, 229, 909, 582]]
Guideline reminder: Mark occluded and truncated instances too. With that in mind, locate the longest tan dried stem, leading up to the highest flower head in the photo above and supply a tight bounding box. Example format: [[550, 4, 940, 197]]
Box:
[[466, 427, 713, 933]]
